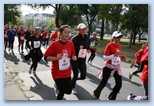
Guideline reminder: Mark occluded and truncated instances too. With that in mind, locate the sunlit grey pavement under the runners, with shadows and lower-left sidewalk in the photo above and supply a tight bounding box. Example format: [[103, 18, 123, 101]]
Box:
[[4, 36, 144, 100]]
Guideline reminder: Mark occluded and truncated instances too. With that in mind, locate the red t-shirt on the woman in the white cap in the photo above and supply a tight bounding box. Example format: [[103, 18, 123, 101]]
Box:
[[104, 42, 121, 64]]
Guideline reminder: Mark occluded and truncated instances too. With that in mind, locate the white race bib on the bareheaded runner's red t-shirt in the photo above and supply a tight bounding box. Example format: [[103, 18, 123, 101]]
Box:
[[59, 57, 70, 71]]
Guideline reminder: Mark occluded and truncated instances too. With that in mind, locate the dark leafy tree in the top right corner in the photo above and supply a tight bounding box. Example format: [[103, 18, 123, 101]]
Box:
[[123, 4, 148, 48]]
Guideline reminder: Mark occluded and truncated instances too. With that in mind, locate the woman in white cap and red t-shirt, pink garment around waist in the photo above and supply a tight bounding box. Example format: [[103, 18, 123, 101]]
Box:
[[93, 31, 126, 100]]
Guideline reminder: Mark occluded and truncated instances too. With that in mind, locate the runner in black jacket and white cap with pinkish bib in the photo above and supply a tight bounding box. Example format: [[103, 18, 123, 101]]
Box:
[[71, 23, 90, 94]]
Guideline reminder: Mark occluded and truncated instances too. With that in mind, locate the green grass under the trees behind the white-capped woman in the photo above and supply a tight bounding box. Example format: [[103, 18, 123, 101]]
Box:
[[96, 37, 146, 63]]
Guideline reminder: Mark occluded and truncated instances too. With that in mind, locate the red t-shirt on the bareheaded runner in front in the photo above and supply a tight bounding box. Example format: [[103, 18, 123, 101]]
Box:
[[44, 40, 75, 79]]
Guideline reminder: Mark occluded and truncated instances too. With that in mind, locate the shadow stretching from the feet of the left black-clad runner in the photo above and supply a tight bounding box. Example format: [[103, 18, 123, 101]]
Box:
[[30, 76, 56, 100]]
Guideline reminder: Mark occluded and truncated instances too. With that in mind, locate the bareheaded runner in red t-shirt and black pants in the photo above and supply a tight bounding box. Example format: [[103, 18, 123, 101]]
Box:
[[44, 25, 77, 100]]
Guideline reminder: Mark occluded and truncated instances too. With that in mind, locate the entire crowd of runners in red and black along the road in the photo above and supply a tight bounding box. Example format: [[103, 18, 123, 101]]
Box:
[[4, 23, 148, 100]]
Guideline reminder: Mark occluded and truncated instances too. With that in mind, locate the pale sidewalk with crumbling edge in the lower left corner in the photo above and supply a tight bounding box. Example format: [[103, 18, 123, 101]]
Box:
[[4, 58, 28, 100]]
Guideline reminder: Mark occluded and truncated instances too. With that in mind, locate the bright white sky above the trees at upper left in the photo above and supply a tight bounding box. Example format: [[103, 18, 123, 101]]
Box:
[[21, 5, 54, 15]]
